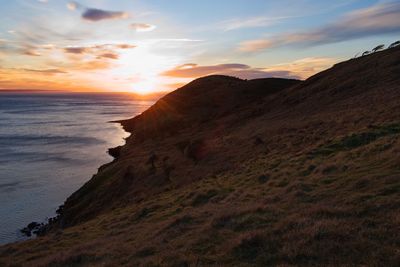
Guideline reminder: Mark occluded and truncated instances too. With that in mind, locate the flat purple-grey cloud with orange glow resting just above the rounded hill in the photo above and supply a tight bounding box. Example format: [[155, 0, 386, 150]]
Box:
[[163, 64, 298, 79]]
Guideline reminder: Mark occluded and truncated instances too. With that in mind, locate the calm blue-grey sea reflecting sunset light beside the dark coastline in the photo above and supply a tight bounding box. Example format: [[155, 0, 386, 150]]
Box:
[[0, 93, 153, 244]]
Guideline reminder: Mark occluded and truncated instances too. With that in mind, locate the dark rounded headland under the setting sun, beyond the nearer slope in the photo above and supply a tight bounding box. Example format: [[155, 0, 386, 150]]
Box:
[[122, 75, 300, 137]]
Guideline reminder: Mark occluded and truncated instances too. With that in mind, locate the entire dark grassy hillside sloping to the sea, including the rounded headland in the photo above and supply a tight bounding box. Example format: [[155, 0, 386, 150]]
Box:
[[0, 47, 400, 266]]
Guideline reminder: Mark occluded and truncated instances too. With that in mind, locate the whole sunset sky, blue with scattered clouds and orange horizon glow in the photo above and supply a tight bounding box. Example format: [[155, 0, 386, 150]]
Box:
[[0, 0, 400, 94]]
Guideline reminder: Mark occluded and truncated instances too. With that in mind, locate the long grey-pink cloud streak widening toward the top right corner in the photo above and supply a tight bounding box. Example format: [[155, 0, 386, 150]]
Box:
[[239, 2, 400, 52]]
